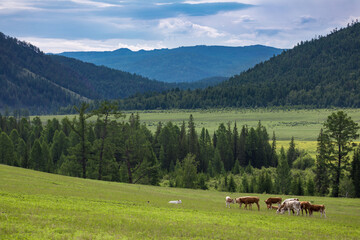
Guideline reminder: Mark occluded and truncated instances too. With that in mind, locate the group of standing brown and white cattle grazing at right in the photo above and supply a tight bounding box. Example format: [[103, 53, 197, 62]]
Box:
[[225, 196, 326, 218]]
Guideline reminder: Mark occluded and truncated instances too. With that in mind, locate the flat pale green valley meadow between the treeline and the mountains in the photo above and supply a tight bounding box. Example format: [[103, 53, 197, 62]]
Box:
[[34, 109, 360, 141]]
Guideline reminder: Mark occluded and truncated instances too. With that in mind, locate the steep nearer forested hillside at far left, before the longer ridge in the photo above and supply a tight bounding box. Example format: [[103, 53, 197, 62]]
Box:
[[0, 33, 98, 113]]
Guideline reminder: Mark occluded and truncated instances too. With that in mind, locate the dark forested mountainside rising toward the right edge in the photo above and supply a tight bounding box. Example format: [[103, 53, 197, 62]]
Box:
[[121, 22, 360, 109]]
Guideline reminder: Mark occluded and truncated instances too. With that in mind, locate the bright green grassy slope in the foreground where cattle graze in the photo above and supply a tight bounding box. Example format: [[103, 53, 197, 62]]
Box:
[[0, 165, 360, 239]]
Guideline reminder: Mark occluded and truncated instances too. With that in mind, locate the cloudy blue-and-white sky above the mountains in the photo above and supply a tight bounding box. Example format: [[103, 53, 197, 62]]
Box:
[[0, 0, 360, 53]]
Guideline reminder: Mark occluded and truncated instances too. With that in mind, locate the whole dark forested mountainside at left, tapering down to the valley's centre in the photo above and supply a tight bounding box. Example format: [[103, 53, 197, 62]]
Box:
[[0, 33, 184, 114]]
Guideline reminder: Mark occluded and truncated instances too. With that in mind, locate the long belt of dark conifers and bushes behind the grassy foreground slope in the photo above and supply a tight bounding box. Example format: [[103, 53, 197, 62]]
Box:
[[0, 102, 360, 196]]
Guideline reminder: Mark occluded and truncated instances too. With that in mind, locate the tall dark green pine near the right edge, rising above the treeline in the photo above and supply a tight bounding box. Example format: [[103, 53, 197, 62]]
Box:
[[315, 111, 360, 197]]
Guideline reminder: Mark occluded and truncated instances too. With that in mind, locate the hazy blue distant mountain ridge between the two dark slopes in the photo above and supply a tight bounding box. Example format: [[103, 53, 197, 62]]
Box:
[[60, 45, 283, 83]]
